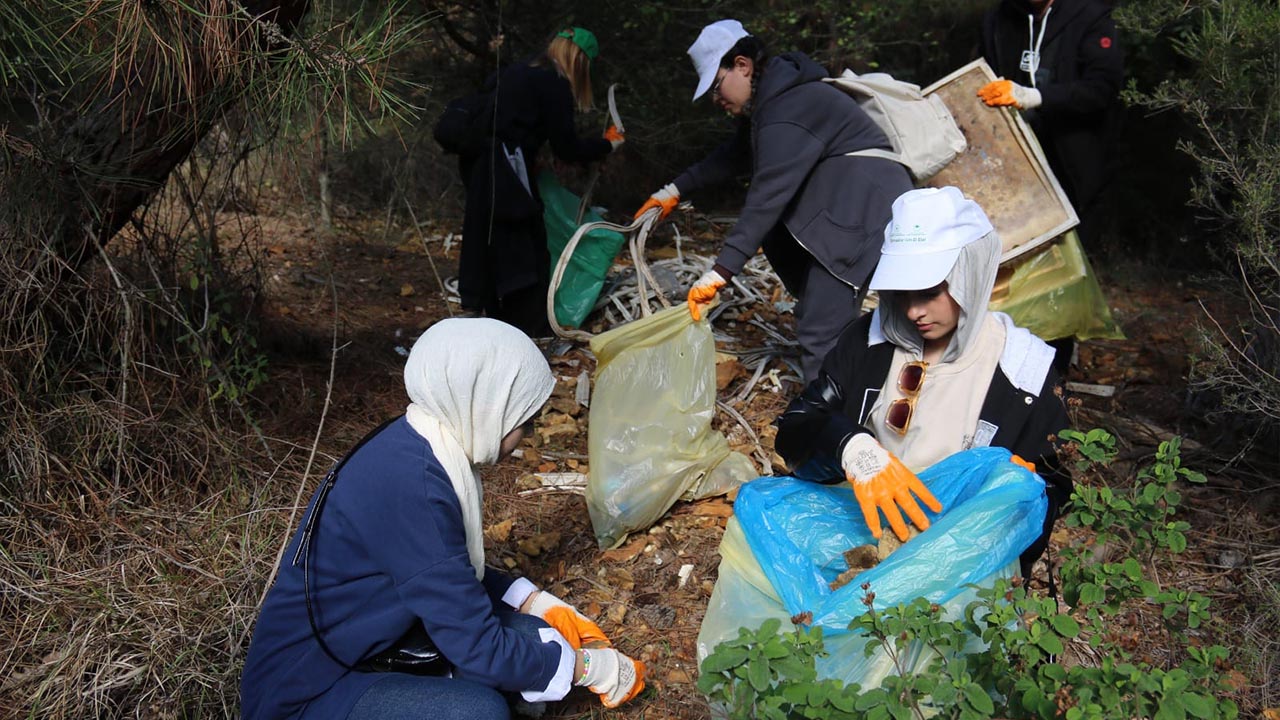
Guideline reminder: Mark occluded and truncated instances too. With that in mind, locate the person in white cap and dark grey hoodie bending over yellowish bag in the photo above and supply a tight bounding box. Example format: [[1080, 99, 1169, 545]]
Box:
[[636, 19, 911, 382]]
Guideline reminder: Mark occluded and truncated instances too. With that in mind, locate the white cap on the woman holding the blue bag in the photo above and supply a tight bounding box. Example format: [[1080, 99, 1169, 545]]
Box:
[[870, 186, 993, 290]]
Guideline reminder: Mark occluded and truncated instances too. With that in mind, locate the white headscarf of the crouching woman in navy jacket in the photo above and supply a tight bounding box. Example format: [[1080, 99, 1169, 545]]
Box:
[[404, 318, 556, 578]]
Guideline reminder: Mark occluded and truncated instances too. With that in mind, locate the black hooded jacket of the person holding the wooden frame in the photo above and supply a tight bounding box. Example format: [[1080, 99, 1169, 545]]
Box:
[[982, 0, 1124, 214]]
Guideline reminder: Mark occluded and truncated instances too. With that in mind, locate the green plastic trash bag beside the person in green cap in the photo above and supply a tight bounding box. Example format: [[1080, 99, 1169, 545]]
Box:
[[538, 170, 626, 328]]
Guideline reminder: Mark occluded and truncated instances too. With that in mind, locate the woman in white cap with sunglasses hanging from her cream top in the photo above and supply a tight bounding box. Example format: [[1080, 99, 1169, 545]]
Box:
[[774, 187, 1071, 577]]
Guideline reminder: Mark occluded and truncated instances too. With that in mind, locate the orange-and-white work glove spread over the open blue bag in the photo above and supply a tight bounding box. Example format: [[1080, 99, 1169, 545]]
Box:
[[840, 433, 942, 542]]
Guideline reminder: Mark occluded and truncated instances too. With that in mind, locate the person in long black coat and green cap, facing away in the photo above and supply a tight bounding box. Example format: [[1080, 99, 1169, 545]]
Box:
[[458, 27, 623, 337]]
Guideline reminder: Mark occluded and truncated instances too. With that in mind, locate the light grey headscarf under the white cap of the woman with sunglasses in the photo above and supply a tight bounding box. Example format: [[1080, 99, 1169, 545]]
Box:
[[879, 231, 1000, 363]]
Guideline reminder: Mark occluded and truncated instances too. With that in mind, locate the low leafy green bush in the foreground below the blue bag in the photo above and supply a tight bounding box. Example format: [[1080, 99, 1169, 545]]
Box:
[[698, 430, 1239, 720]]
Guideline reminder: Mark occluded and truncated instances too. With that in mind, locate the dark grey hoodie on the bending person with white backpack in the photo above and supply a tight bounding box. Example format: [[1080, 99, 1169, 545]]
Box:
[[676, 53, 913, 287]]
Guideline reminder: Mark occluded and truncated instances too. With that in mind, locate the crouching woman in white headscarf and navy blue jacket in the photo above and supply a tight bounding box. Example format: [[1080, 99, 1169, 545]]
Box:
[[241, 319, 644, 720]]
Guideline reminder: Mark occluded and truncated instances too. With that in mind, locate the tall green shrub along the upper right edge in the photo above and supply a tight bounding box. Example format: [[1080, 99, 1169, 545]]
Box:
[[1116, 0, 1280, 452]]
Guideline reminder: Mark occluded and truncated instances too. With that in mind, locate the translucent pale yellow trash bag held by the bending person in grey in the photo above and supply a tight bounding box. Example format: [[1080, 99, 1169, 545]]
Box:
[[586, 304, 758, 550]]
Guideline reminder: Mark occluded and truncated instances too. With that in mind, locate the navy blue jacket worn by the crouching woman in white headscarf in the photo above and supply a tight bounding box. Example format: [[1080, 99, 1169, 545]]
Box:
[[241, 418, 561, 720]]
